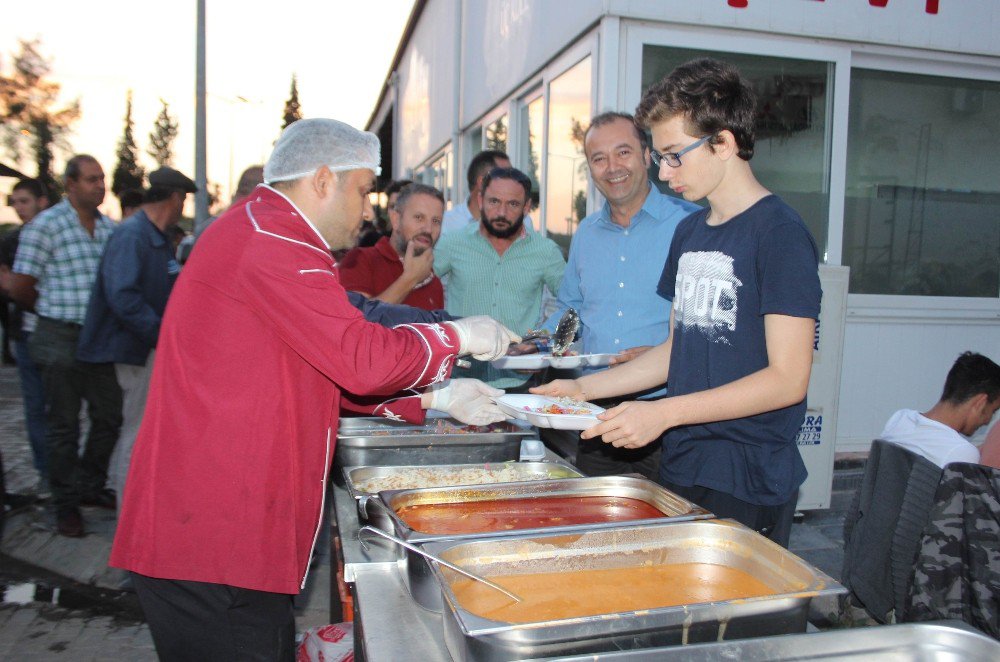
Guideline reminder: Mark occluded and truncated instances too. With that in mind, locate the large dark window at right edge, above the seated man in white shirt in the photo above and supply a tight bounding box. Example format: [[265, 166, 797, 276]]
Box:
[[844, 69, 1000, 297]]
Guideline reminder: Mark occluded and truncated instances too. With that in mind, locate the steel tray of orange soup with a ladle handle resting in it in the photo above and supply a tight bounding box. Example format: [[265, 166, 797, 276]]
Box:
[[424, 520, 845, 661]]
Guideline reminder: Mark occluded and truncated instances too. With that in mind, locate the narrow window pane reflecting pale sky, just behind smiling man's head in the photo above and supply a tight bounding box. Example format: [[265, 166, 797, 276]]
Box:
[[544, 56, 592, 252]]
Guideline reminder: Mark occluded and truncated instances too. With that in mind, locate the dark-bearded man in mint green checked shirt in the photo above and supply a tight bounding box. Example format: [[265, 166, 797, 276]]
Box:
[[434, 168, 566, 391]]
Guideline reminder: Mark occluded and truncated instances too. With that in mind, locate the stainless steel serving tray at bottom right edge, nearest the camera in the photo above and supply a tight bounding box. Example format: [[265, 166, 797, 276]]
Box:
[[536, 621, 1000, 662]]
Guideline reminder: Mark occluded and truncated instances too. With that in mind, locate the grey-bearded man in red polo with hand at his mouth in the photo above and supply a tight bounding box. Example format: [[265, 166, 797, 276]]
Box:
[[337, 184, 444, 310]]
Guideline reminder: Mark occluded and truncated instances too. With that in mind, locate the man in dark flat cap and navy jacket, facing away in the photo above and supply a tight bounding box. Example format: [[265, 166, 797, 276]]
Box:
[[77, 167, 198, 506]]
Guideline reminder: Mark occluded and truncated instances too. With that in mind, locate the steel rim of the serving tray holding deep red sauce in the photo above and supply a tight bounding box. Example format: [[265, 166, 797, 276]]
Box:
[[361, 475, 714, 611]]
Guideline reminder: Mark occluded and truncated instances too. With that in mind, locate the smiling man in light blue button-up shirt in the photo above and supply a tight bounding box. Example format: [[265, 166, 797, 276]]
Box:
[[543, 112, 699, 478]]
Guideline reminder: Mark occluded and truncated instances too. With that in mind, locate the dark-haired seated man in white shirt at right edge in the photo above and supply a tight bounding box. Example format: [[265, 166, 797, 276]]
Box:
[[879, 352, 1000, 468]]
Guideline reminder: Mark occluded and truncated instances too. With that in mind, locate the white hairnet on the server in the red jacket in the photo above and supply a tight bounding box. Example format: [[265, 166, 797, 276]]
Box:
[[264, 118, 382, 184]]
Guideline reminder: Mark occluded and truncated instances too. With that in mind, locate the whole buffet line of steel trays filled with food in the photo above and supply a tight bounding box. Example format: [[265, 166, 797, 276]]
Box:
[[333, 418, 1000, 661]]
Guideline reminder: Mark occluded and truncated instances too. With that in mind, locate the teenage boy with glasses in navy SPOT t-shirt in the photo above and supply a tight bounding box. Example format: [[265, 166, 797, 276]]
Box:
[[535, 59, 821, 546]]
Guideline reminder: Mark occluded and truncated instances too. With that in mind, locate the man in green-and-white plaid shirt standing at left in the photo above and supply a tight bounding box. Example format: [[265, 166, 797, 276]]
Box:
[[11, 154, 122, 537]]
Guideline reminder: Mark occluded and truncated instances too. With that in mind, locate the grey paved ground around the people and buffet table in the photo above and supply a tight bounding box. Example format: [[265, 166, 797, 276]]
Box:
[[0, 366, 860, 662]]
